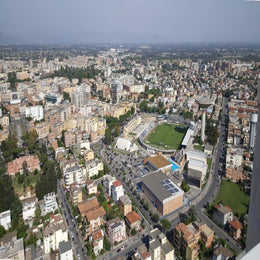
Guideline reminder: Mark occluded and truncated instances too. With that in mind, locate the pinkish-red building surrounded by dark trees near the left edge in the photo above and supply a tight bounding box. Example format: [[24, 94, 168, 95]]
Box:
[[8, 155, 40, 176]]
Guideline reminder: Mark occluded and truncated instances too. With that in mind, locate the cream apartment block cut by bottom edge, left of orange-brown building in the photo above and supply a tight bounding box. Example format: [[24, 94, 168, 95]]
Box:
[[149, 228, 174, 260]]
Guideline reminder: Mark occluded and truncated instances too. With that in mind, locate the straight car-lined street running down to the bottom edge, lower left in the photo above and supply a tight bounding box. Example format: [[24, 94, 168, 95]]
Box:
[[57, 181, 87, 259]]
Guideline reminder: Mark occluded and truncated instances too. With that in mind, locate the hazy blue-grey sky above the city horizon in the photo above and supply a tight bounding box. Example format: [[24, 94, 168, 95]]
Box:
[[0, 0, 260, 43]]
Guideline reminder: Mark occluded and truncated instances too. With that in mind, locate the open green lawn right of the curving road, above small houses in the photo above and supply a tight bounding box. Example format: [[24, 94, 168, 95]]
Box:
[[214, 181, 249, 217]]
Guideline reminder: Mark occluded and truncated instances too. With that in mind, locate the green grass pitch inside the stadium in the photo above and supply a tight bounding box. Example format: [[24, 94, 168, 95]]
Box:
[[145, 124, 187, 149]]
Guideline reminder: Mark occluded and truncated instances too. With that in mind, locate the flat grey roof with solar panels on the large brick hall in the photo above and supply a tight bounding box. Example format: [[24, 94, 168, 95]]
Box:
[[142, 171, 183, 202]]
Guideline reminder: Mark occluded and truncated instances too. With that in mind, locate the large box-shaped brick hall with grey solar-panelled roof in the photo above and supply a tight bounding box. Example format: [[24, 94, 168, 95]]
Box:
[[141, 171, 184, 216]]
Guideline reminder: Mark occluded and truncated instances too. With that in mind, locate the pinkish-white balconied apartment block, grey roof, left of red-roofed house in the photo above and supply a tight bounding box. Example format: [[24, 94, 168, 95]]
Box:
[[106, 217, 126, 244]]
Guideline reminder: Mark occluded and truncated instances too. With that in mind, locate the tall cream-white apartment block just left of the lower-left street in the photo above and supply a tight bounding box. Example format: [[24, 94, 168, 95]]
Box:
[[43, 214, 68, 254]]
